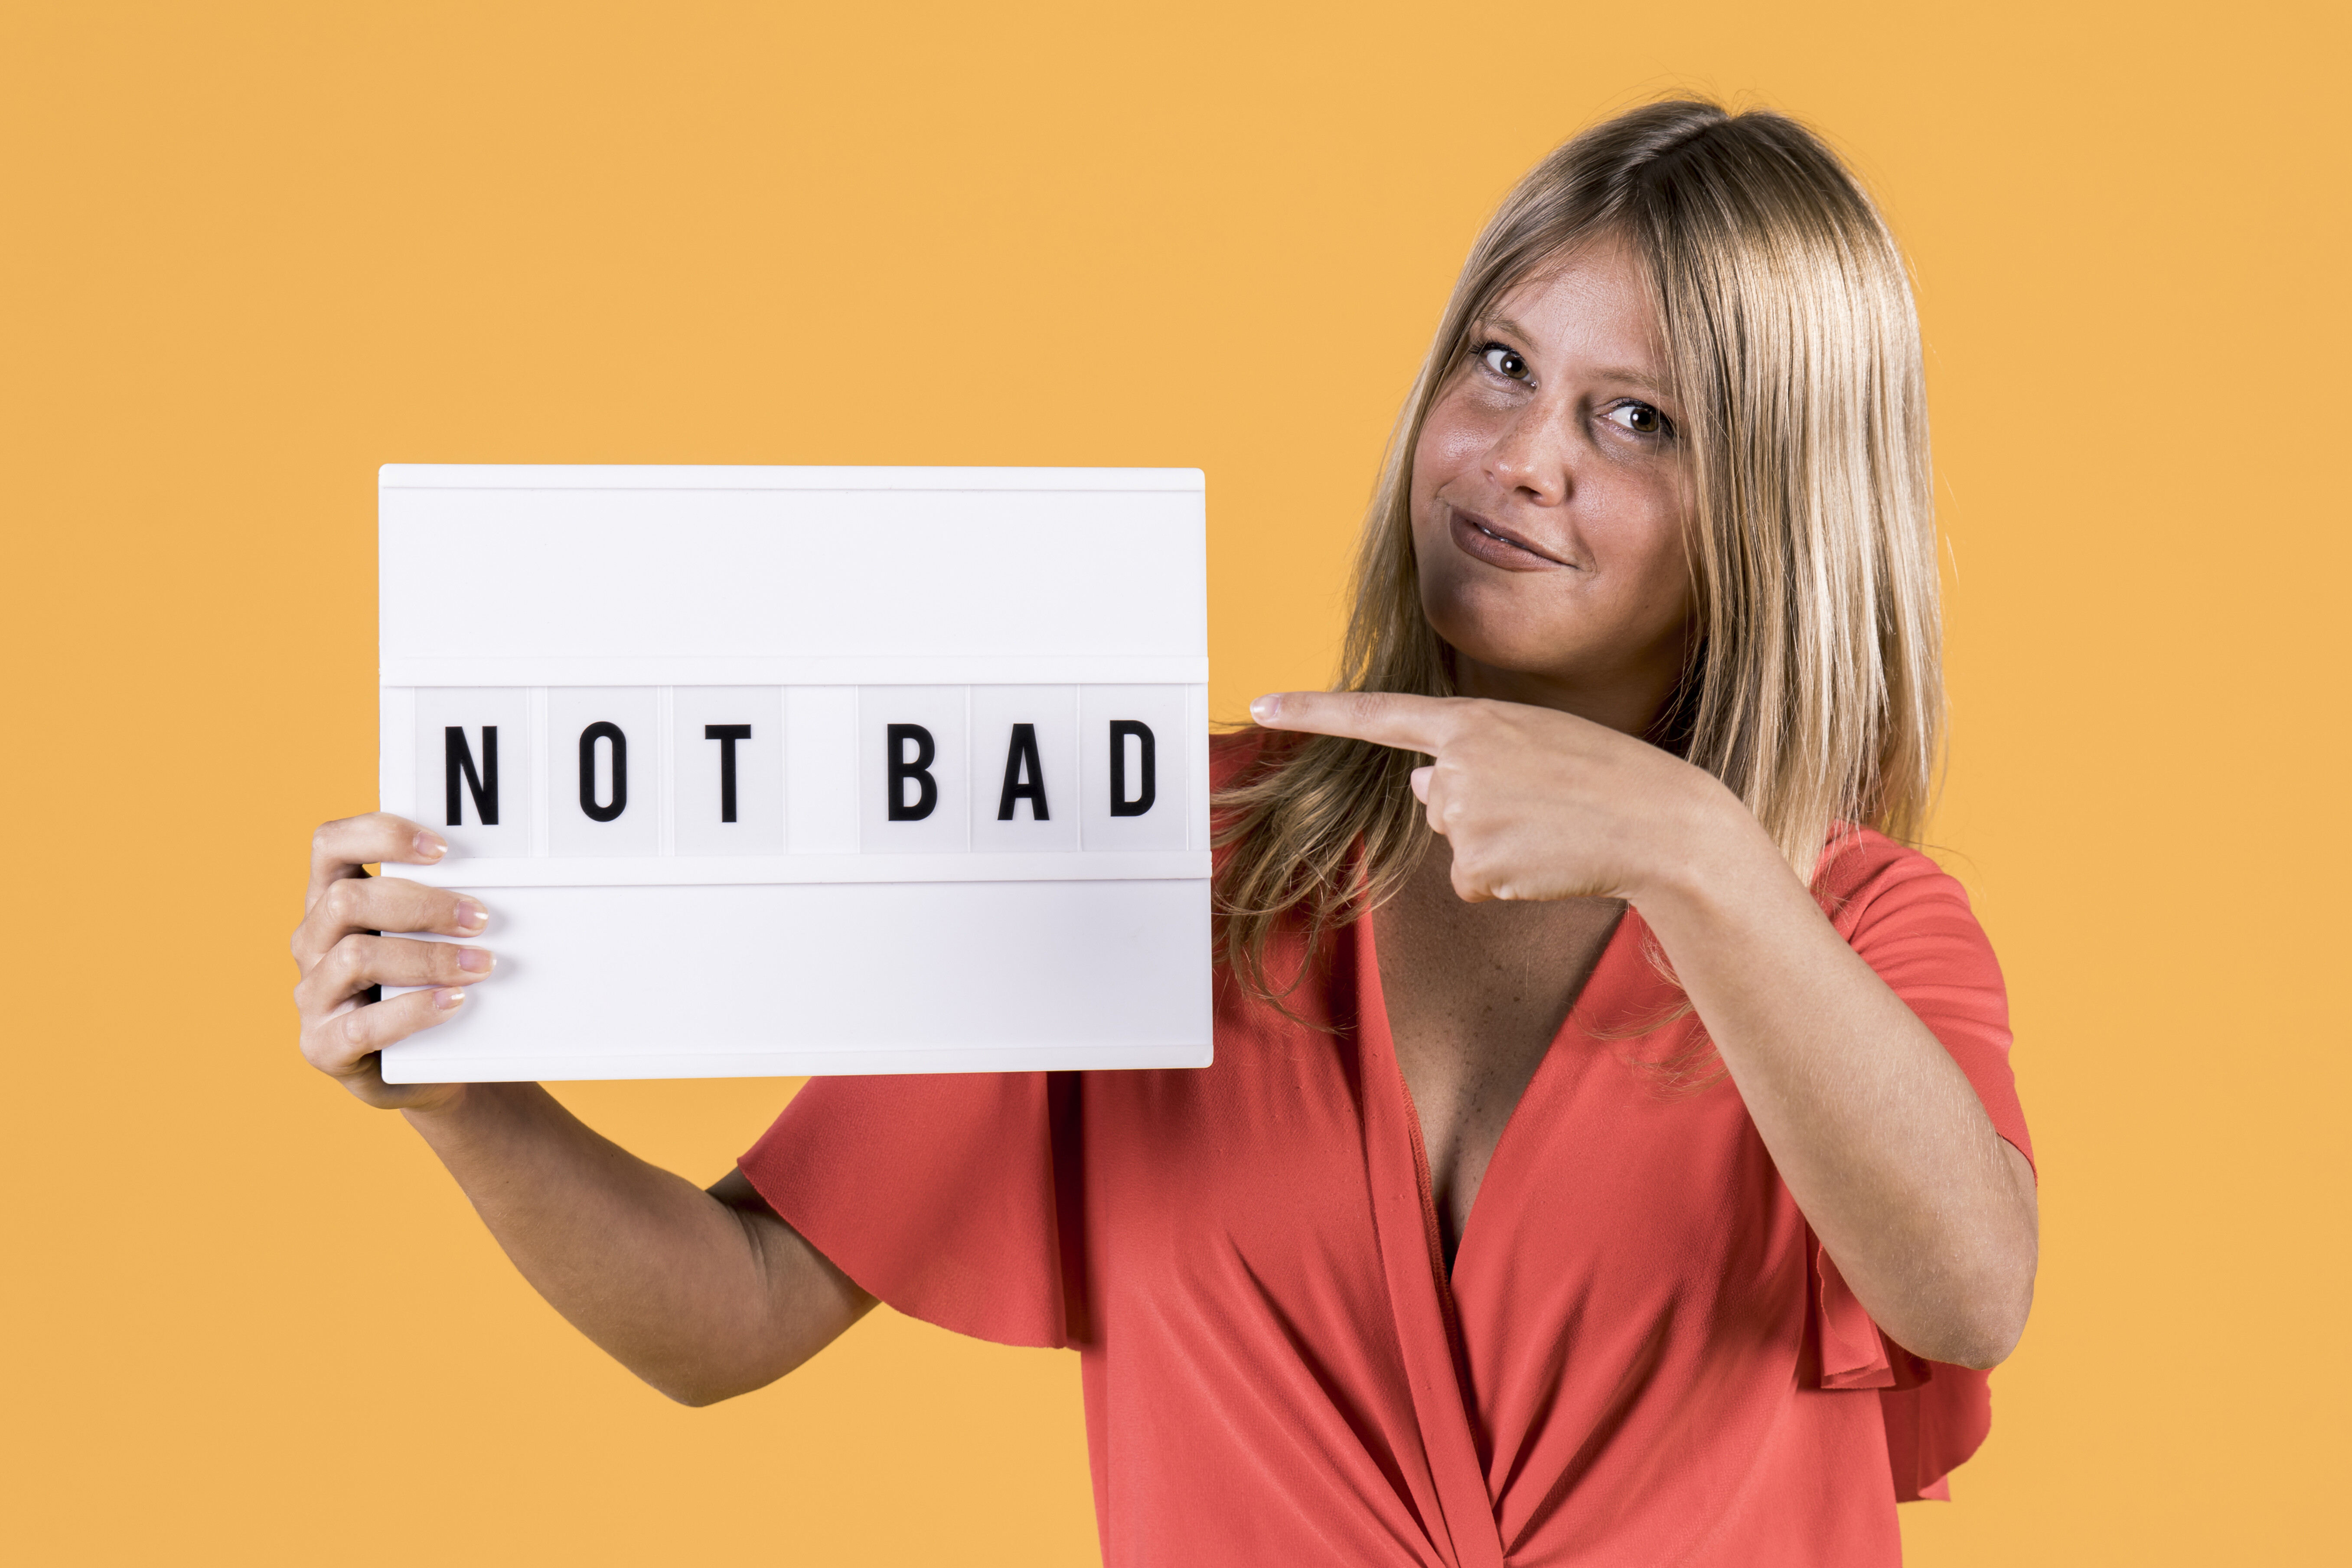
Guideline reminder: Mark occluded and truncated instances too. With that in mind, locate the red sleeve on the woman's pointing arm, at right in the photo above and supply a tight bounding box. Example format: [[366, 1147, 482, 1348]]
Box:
[[1814, 832, 2035, 1502]]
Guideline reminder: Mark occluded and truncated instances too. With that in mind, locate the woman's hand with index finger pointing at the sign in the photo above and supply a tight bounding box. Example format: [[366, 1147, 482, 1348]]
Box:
[[1249, 691, 1764, 905]]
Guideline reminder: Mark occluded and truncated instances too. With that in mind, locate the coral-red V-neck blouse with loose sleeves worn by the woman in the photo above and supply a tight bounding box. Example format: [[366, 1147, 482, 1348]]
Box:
[[741, 743, 2030, 1568]]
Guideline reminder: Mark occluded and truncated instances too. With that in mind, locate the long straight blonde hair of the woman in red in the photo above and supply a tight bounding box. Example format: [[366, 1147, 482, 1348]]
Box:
[[1216, 101, 1943, 997]]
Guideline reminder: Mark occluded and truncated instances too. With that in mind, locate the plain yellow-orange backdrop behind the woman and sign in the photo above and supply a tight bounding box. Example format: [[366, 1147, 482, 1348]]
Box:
[[0, 0, 2352, 1566]]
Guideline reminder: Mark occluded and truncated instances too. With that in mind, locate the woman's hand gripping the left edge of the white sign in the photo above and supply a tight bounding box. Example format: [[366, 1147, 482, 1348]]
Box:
[[294, 811, 496, 1110]]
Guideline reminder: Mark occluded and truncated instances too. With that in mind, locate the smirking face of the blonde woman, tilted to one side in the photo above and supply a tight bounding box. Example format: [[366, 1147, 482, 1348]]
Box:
[[1411, 240, 1691, 733]]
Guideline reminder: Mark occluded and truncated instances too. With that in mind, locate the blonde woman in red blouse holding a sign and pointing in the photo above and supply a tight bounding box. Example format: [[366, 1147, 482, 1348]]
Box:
[[294, 104, 2035, 1566]]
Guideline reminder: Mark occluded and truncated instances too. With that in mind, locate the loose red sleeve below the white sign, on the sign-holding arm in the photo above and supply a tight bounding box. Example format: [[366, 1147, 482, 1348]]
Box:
[[736, 1072, 1075, 1347]]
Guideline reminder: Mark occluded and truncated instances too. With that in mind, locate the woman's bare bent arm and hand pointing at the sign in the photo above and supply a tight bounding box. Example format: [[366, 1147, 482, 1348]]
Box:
[[1251, 691, 2039, 1366]]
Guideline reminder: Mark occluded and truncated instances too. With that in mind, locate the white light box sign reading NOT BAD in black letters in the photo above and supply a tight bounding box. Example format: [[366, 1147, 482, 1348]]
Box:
[[378, 463, 1211, 1084]]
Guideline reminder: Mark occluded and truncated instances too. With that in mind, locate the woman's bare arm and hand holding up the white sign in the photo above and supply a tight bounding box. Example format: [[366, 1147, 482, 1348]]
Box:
[[294, 811, 875, 1406]]
